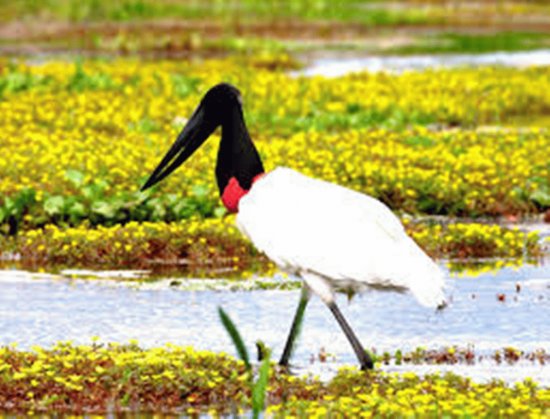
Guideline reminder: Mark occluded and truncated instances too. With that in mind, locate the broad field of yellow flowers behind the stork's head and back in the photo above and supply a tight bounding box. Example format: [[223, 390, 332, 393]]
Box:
[[0, 59, 550, 227]]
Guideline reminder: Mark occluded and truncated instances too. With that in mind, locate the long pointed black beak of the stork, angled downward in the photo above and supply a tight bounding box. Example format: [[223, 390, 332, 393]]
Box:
[[141, 104, 216, 191]]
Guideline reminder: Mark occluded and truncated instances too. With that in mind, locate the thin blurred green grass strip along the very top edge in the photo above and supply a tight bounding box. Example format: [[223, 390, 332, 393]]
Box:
[[3, 0, 441, 26]]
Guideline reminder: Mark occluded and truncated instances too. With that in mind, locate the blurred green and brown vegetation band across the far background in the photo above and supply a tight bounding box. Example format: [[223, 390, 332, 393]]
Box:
[[5, 0, 550, 57]]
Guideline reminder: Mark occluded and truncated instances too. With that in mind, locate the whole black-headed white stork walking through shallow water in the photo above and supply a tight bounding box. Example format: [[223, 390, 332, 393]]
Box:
[[141, 83, 445, 370]]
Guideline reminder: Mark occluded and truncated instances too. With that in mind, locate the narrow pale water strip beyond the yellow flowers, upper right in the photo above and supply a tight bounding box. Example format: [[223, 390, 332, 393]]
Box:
[[293, 49, 550, 77]]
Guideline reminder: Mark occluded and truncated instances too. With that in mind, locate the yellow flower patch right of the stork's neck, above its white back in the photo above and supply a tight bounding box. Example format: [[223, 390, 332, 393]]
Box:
[[259, 128, 550, 215]]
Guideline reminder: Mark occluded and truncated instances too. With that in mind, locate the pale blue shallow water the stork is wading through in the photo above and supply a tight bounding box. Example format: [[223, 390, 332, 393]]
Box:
[[0, 264, 550, 385]]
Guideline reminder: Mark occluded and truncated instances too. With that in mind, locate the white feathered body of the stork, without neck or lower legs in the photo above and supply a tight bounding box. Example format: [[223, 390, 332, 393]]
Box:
[[237, 168, 445, 307]]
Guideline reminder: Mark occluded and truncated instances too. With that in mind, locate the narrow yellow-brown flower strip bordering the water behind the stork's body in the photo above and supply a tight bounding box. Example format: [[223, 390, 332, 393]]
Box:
[[4, 216, 542, 278]]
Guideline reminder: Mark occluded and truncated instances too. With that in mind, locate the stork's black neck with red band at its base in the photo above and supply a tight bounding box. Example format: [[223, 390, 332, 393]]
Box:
[[216, 107, 264, 212]]
